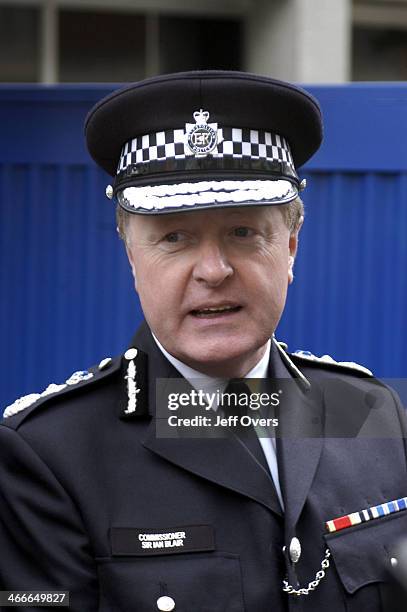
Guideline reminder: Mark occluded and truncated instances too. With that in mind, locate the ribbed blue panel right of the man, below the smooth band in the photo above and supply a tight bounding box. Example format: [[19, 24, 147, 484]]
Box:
[[278, 172, 407, 377]]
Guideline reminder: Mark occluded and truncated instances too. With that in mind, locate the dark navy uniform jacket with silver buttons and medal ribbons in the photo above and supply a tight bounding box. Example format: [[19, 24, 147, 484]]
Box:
[[0, 326, 407, 612]]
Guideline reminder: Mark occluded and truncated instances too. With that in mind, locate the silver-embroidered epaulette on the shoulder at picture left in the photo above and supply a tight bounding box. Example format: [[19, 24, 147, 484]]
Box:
[[3, 357, 121, 419]]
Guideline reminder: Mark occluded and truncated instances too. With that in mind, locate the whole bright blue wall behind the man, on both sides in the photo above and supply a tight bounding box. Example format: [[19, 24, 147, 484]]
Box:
[[0, 84, 407, 405]]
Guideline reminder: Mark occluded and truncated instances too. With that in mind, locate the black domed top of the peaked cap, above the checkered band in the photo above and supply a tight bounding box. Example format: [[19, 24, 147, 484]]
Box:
[[85, 70, 322, 176]]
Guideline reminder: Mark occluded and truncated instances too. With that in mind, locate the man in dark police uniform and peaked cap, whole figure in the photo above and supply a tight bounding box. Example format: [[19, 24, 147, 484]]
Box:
[[0, 71, 407, 612]]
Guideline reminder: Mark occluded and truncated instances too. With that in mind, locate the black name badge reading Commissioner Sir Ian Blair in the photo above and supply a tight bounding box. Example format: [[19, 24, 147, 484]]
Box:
[[110, 525, 215, 557]]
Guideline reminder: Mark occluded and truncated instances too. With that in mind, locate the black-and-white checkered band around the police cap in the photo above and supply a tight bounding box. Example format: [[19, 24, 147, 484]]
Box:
[[117, 127, 295, 174]]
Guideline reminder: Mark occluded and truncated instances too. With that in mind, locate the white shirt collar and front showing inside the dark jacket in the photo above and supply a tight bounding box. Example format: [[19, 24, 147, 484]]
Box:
[[153, 334, 284, 509]]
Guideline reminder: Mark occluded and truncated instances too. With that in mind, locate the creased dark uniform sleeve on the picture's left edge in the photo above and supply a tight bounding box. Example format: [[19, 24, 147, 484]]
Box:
[[0, 426, 98, 612]]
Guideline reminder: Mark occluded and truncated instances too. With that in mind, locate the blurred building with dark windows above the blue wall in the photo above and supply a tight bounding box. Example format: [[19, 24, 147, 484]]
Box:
[[0, 0, 407, 83]]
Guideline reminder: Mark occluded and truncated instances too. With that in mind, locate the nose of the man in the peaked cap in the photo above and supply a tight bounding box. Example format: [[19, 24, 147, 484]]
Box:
[[193, 241, 233, 287]]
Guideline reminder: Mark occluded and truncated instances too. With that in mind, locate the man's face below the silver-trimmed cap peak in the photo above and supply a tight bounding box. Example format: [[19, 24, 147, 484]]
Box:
[[127, 206, 298, 377]]
